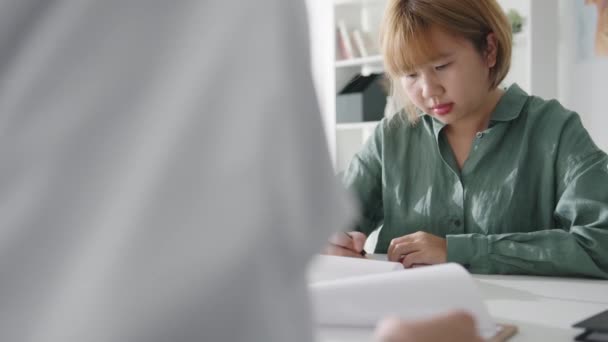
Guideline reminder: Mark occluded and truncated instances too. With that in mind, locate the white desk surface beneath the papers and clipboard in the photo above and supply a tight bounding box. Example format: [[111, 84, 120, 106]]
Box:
[[318, 275, 608, 342]]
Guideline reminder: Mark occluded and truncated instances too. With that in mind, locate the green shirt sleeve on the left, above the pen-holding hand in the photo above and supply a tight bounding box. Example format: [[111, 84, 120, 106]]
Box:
[[342, 120, 387, 235]]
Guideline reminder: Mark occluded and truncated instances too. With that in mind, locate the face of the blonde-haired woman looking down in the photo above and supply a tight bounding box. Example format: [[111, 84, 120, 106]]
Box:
[[401, 28, 496, 125]]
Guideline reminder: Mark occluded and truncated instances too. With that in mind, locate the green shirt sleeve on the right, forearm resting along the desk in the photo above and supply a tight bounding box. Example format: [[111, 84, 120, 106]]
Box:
[[447, 115, 608, 279]]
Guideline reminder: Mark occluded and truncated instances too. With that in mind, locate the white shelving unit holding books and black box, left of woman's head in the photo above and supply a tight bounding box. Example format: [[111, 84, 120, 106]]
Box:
[[308, 0, 386, 171]]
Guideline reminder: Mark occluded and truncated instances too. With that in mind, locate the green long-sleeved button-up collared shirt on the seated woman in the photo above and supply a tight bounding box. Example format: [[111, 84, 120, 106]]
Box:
[[343, 85, 608, 278]]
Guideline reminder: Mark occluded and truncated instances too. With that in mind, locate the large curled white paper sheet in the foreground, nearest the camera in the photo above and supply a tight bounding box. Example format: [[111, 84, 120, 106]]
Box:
[[310, 260, 496, 338]]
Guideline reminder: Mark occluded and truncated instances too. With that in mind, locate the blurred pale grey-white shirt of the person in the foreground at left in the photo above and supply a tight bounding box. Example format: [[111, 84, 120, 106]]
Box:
[[0, 0, 352, 342]]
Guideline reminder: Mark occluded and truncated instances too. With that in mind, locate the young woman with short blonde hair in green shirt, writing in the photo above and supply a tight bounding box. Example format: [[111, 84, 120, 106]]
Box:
[[327, 0, 608, 278]]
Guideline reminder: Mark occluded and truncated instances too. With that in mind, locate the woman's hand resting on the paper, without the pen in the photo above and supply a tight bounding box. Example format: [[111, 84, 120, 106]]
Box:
[[387, 232, 448, 268]]
